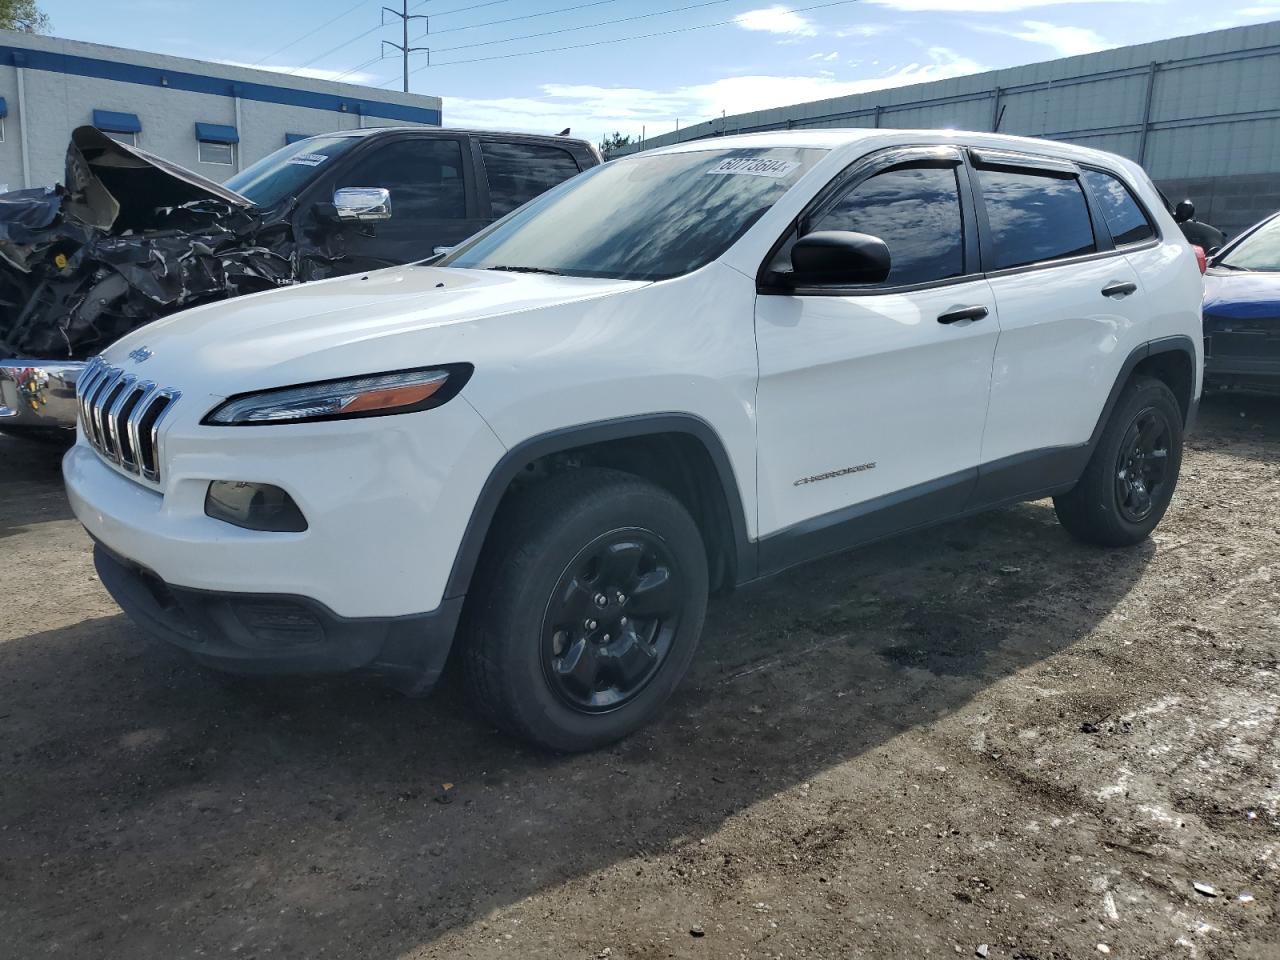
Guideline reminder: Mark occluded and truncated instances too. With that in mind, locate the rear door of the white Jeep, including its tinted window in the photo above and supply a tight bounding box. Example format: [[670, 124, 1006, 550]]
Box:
[[972, 151, 1148, 471]]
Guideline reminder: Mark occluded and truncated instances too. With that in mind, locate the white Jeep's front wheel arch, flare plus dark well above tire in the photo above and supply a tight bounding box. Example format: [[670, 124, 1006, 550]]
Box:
[[444, 413, 756, 598]]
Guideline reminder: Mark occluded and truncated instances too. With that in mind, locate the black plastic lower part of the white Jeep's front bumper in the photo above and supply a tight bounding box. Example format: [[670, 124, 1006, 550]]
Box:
[[93, 544, 462, 694]]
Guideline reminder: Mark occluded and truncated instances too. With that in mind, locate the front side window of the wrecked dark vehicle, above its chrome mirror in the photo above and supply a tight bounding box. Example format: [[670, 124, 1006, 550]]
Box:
[[334, 137, 467, 220]]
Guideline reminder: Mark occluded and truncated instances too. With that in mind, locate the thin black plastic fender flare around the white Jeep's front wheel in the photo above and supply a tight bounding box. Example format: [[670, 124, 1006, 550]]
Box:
[[444, 413, 756, 599]]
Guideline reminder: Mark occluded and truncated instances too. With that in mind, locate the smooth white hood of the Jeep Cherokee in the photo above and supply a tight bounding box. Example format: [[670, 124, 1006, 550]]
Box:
[[102, 265, 648, 397]]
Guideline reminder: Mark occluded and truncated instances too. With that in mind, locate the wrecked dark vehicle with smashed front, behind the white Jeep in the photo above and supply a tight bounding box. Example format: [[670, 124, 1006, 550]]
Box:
[[0, 127, 600, 431]]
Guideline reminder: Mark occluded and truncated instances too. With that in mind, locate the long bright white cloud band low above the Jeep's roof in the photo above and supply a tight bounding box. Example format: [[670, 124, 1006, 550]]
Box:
[[440, 47, 986, 140]]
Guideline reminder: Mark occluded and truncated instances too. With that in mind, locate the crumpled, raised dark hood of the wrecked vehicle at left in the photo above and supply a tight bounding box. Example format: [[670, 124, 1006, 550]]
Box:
[[65, 127, 252, 233]]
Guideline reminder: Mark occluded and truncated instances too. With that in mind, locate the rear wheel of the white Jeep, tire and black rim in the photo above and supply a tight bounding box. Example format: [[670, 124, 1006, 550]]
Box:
[[1053, 376, 1183, 547]]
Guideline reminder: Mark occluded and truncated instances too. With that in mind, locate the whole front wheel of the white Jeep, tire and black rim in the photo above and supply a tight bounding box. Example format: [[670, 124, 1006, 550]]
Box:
[[463, 468, 708, 753]]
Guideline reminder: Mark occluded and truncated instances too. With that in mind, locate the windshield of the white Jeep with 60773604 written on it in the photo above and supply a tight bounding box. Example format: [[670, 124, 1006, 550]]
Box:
[[436, 147, 826, 280]]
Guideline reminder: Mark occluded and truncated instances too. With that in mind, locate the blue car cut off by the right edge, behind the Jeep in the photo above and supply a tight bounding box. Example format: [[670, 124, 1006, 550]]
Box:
[[1204, 212, 1280, 396]]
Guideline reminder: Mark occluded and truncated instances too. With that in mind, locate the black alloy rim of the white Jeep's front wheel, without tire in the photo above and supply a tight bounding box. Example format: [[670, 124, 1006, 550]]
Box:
[[543, 529, 684, 713]]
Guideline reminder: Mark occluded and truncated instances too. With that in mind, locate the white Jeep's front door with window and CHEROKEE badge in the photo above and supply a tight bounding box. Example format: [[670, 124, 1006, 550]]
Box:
[[755, 147, 1000, 570]]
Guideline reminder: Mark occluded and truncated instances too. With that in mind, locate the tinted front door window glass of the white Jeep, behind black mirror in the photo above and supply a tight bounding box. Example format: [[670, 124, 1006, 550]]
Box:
[[809, 166, 964, 287]]
